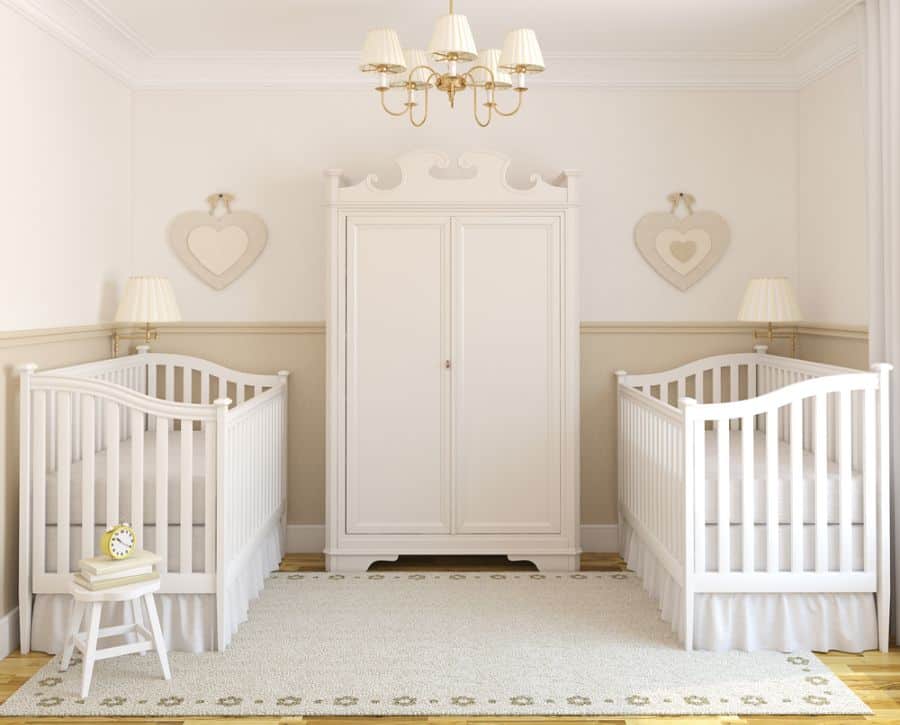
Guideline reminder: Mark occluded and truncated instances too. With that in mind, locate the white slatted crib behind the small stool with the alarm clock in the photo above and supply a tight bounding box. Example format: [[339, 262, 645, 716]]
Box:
[[19, 347, 288, 652]]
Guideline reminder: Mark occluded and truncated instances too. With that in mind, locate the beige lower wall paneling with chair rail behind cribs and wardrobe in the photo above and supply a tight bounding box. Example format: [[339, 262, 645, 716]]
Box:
[[0, 322, 868, 624]]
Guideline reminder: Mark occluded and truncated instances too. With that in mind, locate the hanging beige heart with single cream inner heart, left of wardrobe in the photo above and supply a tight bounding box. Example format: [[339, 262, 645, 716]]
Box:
[[169, 194, 268, 290]]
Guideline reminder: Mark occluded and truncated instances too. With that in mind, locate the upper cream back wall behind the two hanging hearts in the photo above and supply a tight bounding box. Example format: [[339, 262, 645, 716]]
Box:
[[132, 88, 797, 321]]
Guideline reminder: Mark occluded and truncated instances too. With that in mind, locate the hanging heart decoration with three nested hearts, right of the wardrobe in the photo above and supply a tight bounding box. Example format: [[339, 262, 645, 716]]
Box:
[[634, 195, 731, 292]]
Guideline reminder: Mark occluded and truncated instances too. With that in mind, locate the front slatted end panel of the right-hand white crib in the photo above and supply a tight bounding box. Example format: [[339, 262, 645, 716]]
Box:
[[686, 365, 890, 614]]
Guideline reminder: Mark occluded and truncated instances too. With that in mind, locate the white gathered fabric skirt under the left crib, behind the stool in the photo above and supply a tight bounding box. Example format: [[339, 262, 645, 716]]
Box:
[[31, 526, 284, 654]]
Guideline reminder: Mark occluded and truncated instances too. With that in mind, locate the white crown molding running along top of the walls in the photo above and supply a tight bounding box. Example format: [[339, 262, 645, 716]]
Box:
[[0, 0, 860, 91]]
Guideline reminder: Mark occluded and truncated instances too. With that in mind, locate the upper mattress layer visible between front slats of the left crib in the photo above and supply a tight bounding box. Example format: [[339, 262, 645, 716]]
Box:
[[46, 431, 206, 526]]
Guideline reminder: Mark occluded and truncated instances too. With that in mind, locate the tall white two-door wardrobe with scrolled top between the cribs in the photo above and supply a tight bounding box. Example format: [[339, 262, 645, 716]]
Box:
[[325, 152, 580, 572]]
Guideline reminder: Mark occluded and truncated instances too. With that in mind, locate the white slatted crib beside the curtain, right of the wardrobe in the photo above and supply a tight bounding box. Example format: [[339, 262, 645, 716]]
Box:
[[616, 347, 891, 651]]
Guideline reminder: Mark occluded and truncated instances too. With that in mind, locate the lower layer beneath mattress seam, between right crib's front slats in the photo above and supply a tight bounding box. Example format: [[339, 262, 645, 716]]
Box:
[[706, 524, 863, 572]]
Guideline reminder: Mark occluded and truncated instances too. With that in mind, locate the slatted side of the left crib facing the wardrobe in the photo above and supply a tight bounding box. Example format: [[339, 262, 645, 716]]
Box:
[[215, 372, 287, 650]]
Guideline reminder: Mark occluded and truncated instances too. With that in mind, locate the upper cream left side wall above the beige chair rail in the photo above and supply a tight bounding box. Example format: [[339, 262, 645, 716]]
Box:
[[0, 4, 131, 330]]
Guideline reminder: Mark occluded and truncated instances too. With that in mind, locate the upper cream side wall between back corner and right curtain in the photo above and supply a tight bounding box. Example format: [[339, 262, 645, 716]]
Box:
[[797, 58, 868, 324]]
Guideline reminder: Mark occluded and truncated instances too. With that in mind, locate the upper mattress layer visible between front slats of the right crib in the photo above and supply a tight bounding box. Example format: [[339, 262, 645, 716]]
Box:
[[706, 430, 863, 524]]
